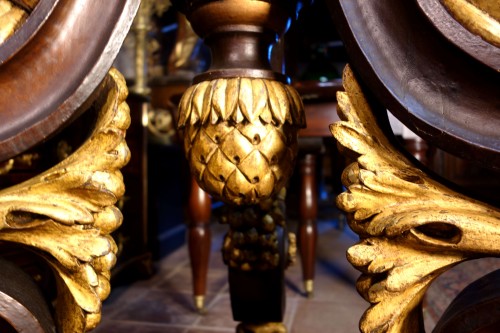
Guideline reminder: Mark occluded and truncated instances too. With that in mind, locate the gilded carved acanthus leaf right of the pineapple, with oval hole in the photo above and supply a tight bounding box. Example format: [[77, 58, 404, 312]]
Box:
[[331, 67, 500, 333]]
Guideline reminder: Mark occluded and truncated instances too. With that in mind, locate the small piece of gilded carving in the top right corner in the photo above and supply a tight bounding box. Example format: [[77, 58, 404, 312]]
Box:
[[441, 0, 500, 47]]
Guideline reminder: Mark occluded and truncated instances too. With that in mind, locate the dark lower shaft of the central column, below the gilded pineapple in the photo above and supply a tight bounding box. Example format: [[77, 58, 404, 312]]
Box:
[[221, 190, 289, 333]]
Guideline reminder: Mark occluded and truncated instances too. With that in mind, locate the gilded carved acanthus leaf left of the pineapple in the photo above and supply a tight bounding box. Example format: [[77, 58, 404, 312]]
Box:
[[0, 70, 130, 333]]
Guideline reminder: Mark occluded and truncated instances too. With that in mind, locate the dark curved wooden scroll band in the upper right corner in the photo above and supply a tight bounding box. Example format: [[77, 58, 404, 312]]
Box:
[[328, 0, 500, 168]]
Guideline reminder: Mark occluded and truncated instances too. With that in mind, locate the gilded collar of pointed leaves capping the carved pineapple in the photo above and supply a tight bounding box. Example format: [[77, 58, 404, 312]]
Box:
[[178, 78, 306, 128]]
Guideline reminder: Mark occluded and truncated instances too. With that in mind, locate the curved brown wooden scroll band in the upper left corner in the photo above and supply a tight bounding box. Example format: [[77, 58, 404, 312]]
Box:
[[0, 0, 139, 161]]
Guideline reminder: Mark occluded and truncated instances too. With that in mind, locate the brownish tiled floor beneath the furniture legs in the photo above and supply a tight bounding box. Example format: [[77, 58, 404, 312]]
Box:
[[95, 217, 368, 333]]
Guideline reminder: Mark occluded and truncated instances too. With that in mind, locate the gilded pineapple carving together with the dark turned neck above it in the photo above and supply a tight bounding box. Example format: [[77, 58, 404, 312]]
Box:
[[178, 0, 305, 205]]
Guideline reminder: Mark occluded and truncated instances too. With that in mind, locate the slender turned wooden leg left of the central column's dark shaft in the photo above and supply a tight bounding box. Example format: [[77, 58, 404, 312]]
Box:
[[188, 178, 211, 312]]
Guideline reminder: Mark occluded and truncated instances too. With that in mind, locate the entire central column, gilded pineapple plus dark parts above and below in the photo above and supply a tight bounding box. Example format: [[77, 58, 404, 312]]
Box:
[[173, 0, 305, 332]]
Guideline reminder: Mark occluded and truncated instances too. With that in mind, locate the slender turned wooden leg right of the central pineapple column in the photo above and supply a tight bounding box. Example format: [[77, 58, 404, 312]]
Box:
[[298, 154, 318, 297]]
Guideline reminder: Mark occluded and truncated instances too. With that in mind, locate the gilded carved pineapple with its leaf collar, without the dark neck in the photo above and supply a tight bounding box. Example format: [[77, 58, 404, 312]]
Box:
[[179, 78, 305, 205]]
